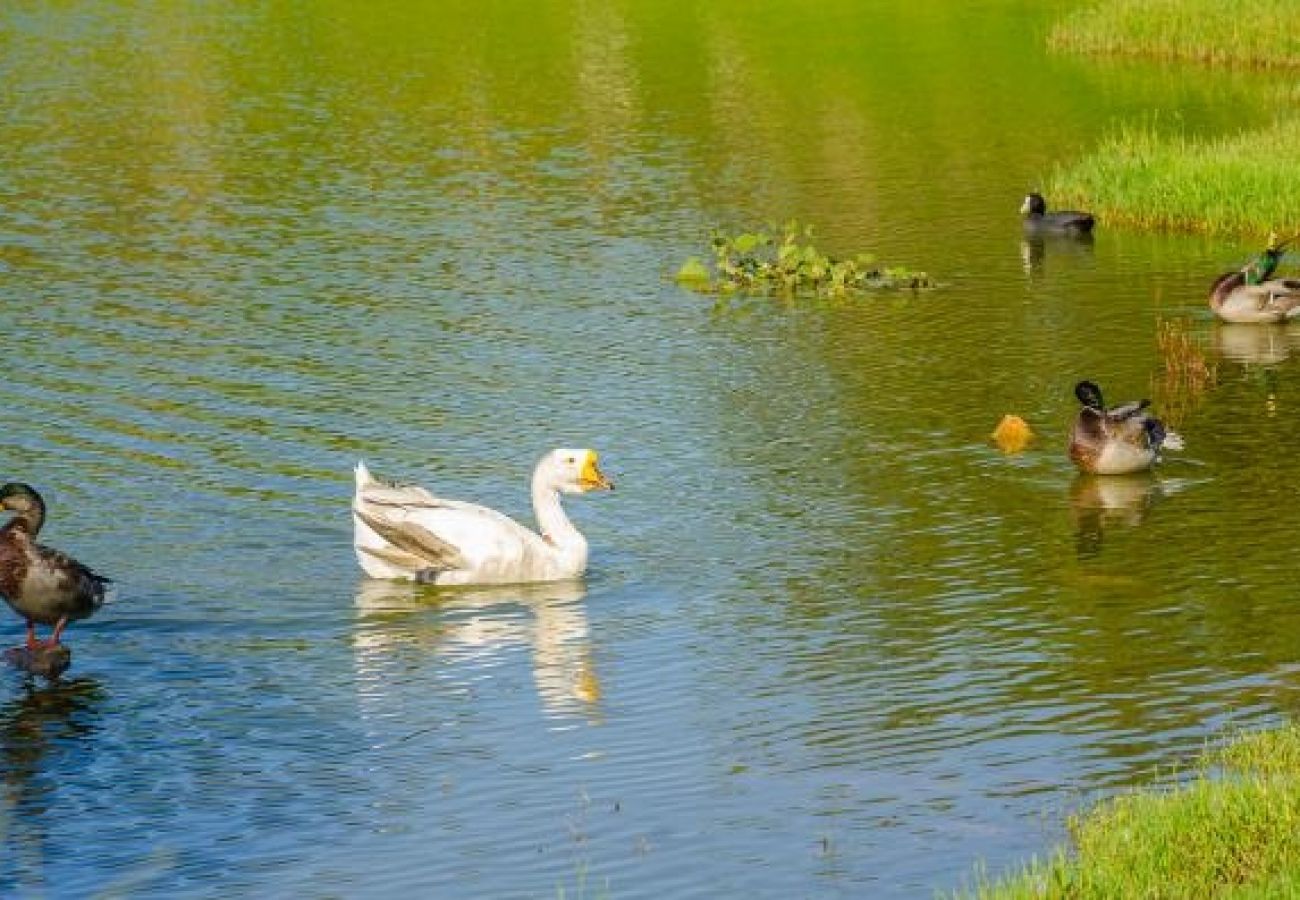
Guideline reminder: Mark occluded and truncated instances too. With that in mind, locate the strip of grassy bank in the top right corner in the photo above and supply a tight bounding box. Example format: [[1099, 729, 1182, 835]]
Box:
[[1048, 0, 1300, 66]]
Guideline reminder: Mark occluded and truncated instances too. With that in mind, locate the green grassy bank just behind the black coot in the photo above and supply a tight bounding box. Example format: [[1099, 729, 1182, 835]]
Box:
[[1048, 117, 1300, 237]]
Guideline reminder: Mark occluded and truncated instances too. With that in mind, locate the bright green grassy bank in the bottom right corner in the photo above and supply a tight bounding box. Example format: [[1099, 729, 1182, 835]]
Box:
[[958, 726, 1300, 900]]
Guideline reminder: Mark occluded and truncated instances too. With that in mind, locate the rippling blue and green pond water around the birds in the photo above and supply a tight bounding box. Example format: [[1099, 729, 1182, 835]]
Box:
[[0, 0, 1300, 897]]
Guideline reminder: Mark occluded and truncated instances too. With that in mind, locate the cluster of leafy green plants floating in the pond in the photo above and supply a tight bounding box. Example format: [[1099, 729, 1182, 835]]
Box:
[[676, 221, 935, 298]]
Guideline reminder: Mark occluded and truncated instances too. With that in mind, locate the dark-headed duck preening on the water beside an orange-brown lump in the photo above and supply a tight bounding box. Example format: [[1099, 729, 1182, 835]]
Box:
[[1070, 381, 1183, 475]]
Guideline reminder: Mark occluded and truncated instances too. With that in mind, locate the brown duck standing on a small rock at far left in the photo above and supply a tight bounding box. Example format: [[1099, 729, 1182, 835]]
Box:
[[0, 483, 112, 649]]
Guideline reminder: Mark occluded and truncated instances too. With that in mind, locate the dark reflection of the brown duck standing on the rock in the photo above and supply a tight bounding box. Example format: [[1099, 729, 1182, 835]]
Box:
[[0, 678, 104, 896]]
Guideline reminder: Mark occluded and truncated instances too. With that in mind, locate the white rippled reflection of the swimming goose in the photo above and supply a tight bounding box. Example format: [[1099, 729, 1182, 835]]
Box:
[[352, 579, 601, 717]]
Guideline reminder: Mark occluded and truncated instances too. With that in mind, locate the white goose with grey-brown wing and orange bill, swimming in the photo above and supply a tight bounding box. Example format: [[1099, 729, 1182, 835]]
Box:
[[352, 450, 614, 584]]
